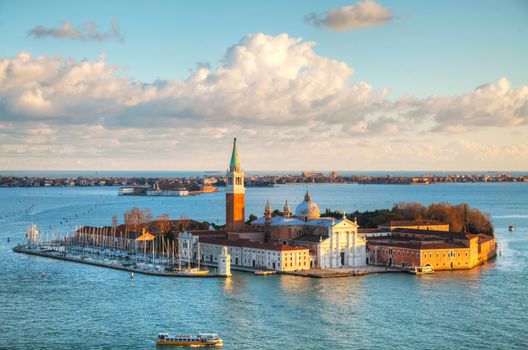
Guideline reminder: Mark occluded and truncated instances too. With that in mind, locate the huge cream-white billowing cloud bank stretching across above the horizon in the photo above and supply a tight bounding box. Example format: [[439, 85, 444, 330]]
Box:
[[0, 34, 528, 169]]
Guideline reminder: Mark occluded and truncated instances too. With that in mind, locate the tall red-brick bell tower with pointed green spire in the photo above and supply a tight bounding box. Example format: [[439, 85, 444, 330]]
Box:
[[226, 138, 245, 231]]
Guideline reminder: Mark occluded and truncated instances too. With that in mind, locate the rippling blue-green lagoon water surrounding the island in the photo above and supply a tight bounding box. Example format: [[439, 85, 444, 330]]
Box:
[[0, 183, 528, 349]]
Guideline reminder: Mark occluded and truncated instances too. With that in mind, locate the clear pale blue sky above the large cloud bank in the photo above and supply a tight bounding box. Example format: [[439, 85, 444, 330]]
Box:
[[4, 0, 528, 96]]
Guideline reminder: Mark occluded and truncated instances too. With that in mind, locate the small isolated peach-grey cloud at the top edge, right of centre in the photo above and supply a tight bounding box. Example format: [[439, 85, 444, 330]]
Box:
[[305, 0, 394, 31]]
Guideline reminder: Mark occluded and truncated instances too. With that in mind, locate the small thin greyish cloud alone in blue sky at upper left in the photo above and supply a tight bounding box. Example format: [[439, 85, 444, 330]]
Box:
[[28, 20, 124, 42]]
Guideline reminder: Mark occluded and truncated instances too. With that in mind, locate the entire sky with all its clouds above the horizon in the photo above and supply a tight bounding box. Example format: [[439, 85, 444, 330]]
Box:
[[0, 0, 528, 173]]
